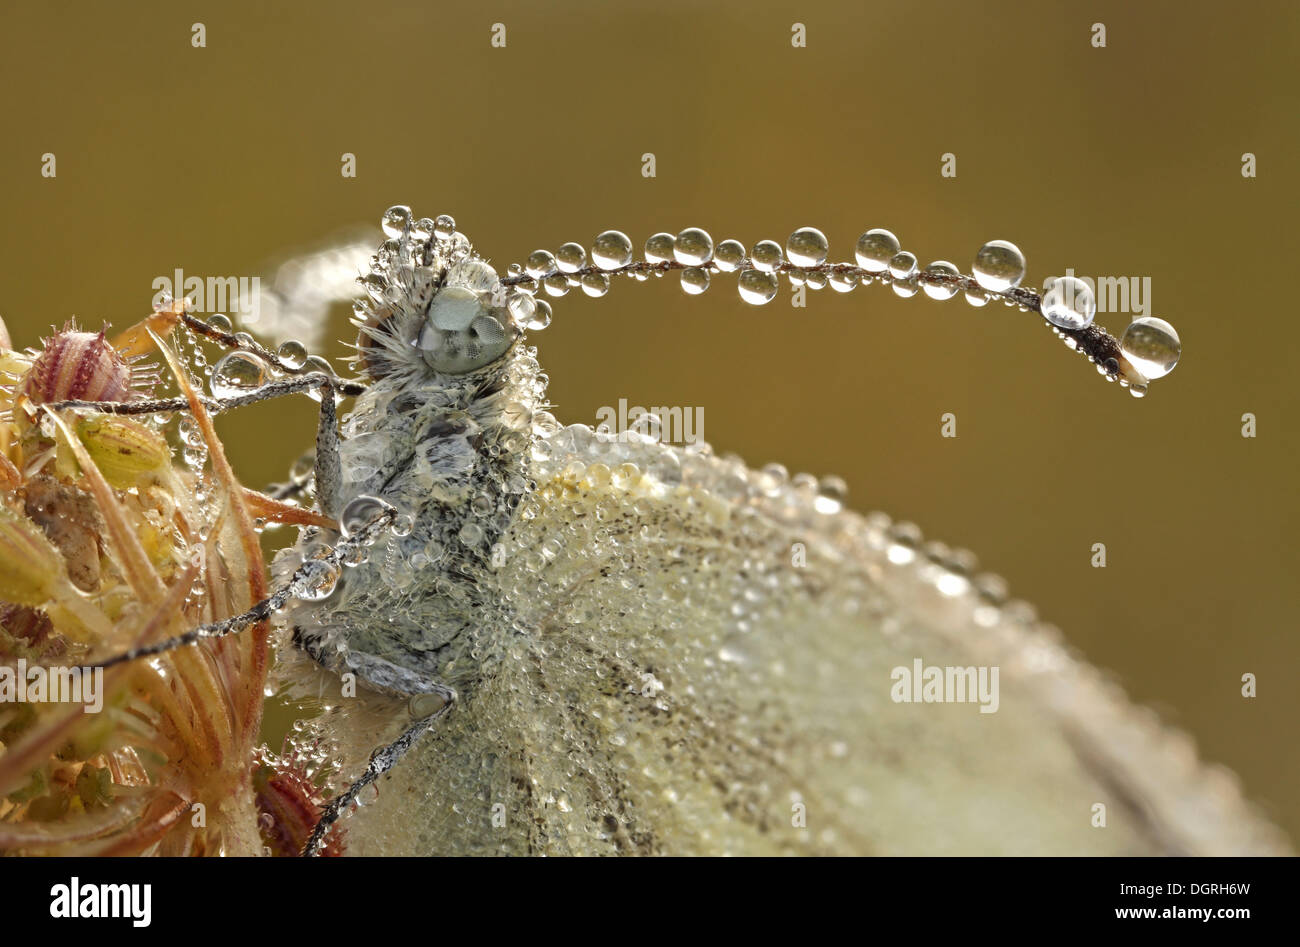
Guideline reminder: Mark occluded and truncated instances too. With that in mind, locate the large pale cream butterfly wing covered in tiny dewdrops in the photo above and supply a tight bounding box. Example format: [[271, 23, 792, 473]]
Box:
[[350, 425, 1286, 855]]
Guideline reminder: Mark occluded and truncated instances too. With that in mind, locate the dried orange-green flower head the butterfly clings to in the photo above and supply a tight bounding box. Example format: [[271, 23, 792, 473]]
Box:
[[0, 307, 284, 855]]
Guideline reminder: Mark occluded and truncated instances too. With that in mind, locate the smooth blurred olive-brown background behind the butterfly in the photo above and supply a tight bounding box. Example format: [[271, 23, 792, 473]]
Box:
[[0, 0, 1300, 838]]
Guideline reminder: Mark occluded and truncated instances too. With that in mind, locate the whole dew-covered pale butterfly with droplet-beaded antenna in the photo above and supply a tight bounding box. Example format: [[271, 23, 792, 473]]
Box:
[[53, 207, 1287, 855]]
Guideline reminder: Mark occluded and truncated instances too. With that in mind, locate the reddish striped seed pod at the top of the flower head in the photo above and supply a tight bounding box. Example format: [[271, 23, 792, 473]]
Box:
[[20, 325, 133, 405]]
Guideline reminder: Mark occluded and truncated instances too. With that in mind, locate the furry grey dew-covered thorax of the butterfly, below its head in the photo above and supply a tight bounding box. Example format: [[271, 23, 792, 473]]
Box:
[[286, 345, 545, 693]]
